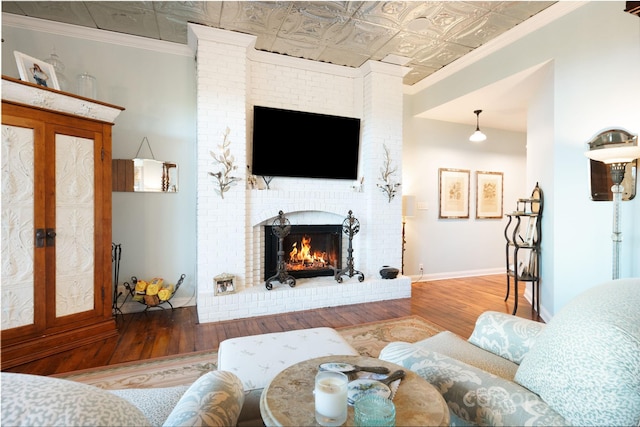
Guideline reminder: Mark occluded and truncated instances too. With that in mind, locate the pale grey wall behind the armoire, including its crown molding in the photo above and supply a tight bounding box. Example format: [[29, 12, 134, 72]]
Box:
[[2, 14, 196, 309]]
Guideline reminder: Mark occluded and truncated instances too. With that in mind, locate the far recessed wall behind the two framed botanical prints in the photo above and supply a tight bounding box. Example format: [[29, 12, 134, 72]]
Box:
[[402, 116, 533, 283]]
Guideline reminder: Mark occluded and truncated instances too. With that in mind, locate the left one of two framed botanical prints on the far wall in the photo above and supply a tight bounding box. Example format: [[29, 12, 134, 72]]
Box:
[[438, 168, 469, 218]]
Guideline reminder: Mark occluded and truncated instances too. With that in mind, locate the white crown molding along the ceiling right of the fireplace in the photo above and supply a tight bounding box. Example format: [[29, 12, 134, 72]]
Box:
[[404, 1, 588, 95]]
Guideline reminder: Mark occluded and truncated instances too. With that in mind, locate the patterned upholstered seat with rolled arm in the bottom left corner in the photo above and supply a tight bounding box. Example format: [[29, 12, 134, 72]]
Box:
[[0, 371, 244, 427]]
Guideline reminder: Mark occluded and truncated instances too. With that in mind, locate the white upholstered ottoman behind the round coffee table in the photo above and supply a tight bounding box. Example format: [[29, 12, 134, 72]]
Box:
[[218, 328, 358, 425]]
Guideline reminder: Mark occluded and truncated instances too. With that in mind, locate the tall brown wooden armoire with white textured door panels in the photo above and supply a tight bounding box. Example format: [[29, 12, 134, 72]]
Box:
[[0, 76, 123, 370]]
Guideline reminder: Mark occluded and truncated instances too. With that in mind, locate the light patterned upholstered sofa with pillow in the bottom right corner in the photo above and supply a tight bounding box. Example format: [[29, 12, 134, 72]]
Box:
[[380, 278, 640, 426]]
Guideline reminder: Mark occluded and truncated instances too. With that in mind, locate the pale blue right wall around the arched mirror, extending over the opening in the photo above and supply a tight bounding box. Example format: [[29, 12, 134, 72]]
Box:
[[404, 1, 640, 315]]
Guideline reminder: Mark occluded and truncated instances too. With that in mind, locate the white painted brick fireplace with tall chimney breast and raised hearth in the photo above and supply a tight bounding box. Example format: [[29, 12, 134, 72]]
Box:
[[189, 24, 411, 322]]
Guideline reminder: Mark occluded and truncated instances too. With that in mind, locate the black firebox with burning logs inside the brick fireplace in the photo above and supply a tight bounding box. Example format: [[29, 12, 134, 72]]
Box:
[[264, 225, 342, 280]]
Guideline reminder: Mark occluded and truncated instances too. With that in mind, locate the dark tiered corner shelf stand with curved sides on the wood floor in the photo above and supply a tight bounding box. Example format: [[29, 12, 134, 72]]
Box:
[[504, 183, 544, 314]]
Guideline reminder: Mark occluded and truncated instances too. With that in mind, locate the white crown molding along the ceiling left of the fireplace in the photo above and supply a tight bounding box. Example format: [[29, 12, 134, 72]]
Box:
[[2, 12, 193, 57]]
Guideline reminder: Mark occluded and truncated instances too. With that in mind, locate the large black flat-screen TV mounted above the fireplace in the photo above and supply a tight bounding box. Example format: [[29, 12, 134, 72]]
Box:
[[251, 106, 360, 180]]
